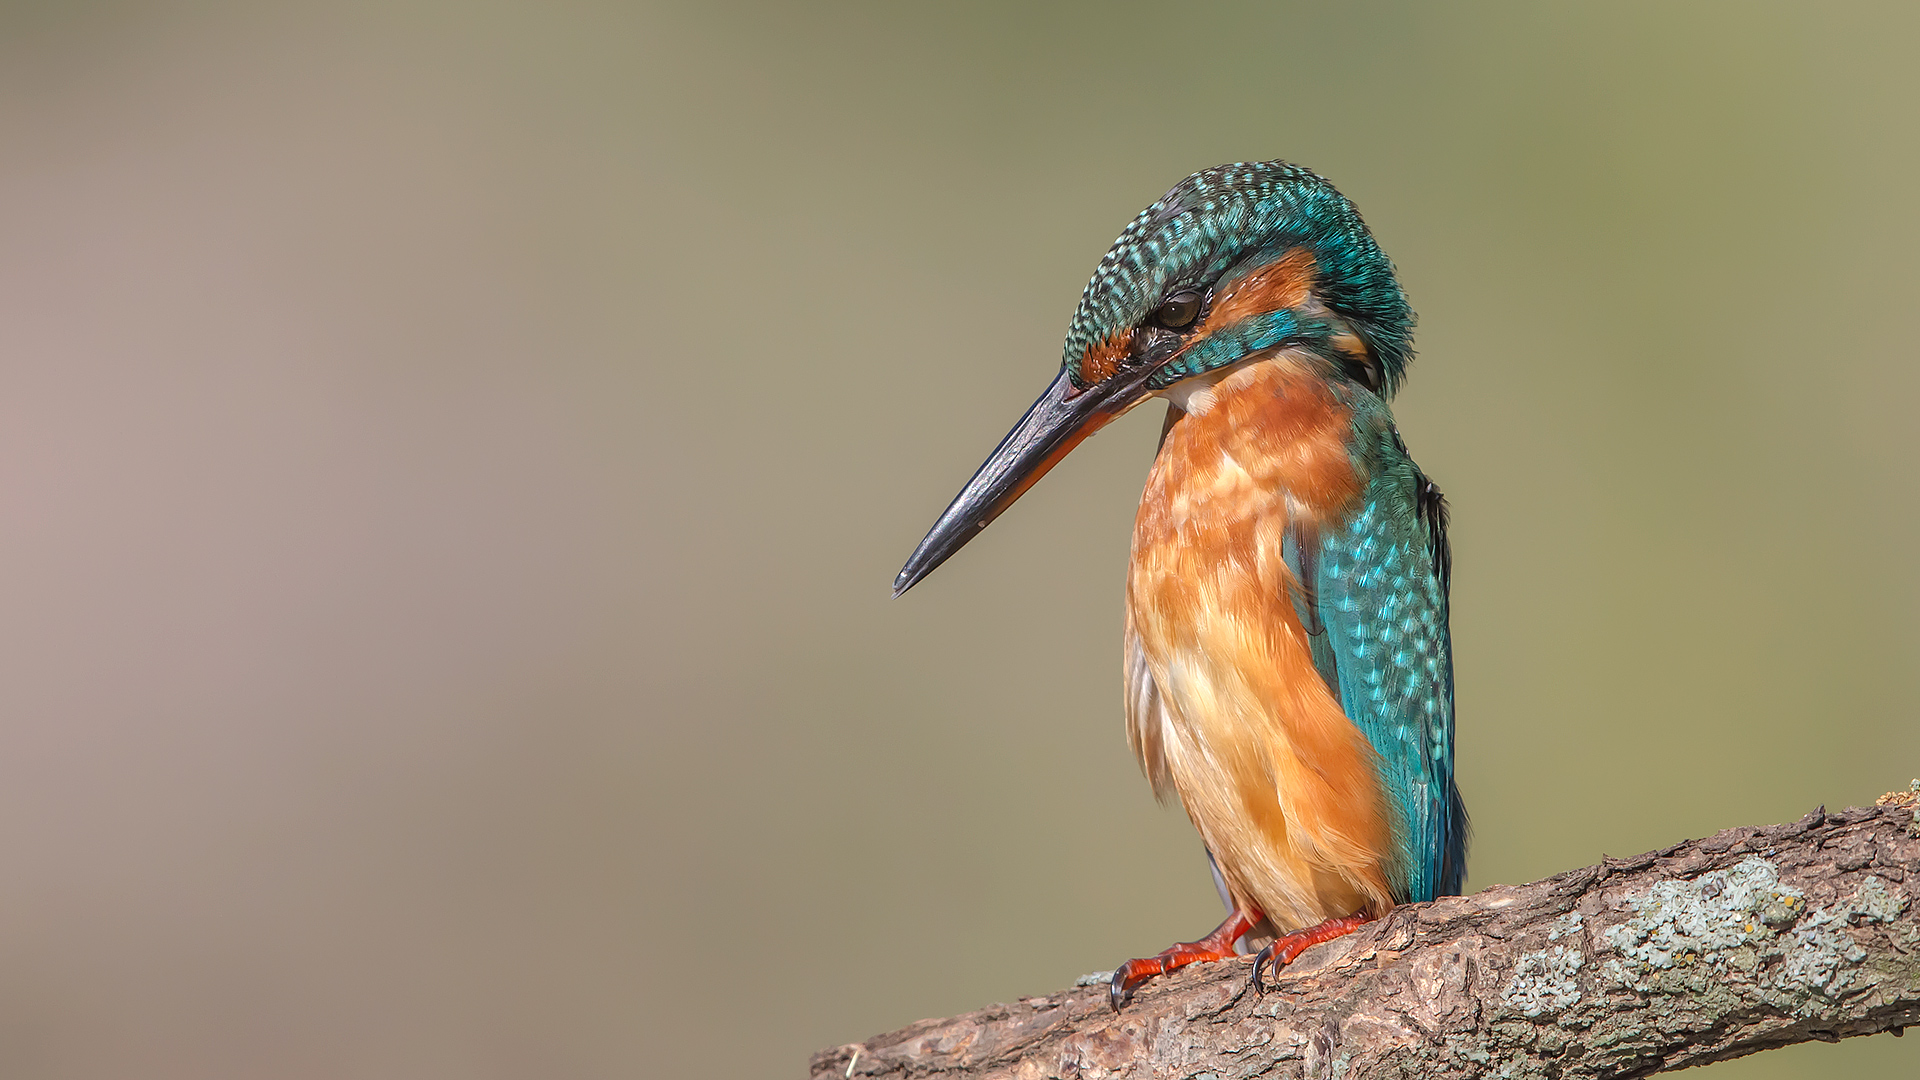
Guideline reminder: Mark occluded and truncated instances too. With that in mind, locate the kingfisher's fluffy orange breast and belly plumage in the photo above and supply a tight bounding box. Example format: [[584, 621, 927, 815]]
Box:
[[1127, 356, 1392, 932]]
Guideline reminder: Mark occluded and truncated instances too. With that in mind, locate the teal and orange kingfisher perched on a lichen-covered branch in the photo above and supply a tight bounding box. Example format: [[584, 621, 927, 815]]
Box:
[[893, 161, 1469, 1011]]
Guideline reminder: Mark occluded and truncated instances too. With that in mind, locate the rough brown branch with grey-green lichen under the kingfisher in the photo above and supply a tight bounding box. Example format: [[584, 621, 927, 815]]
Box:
[[812, 794, 1920, 1080]]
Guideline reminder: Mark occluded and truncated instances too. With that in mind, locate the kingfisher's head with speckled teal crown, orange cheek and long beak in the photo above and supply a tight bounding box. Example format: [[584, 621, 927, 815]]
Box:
[[893, 161, 1413, 596]]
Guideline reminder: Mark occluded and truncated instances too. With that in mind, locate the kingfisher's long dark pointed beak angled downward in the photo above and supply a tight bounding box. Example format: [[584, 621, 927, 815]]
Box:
[[893, 369, 1144, 596]]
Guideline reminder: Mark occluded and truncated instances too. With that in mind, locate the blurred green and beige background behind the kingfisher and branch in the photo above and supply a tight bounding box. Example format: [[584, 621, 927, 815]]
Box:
[[0, 2, 1920, 1080]]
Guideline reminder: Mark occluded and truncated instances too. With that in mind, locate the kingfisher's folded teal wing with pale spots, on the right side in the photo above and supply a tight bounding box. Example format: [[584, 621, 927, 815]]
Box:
[[1286, 436, 1467, 901]]
